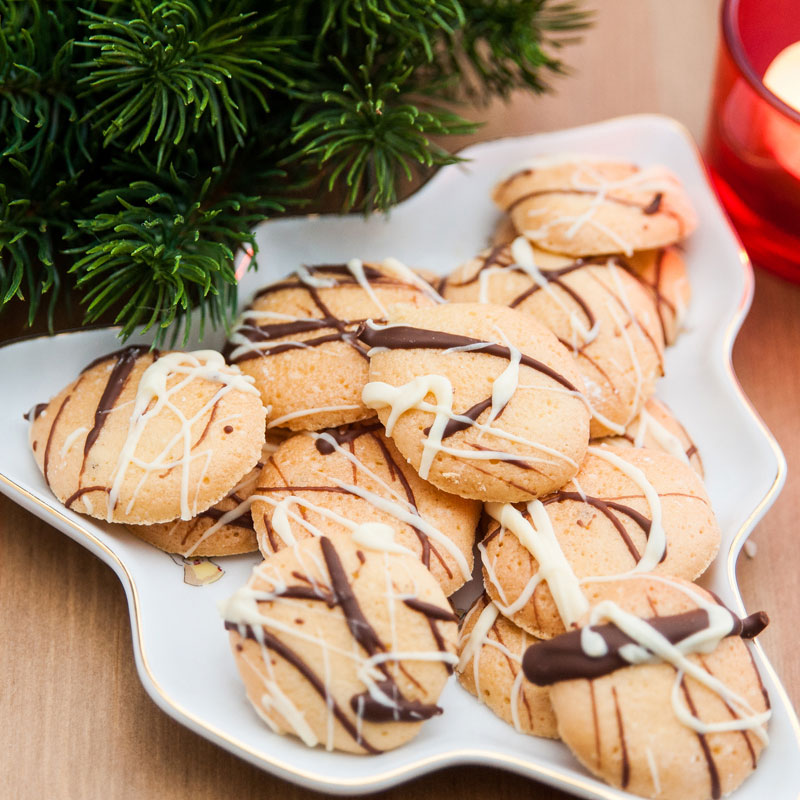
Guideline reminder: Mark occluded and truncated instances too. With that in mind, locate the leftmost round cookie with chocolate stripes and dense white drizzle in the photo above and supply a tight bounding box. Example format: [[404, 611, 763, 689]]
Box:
[[30, 347, 265, 524]]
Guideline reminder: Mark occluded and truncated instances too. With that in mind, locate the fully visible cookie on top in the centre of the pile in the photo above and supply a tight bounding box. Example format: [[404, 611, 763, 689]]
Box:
[[360, 303, 589, 501]]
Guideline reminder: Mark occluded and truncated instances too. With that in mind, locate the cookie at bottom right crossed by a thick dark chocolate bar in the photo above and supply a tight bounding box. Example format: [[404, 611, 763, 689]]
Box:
[[523, 575, 769, 800]]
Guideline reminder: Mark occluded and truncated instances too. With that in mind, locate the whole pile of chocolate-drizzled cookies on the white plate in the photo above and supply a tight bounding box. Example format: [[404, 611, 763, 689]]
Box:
[[31, 156, 769, 800]]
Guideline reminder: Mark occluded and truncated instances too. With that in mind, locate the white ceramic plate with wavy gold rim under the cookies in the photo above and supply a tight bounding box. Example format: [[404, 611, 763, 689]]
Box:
[[0, 116, 800, 800]]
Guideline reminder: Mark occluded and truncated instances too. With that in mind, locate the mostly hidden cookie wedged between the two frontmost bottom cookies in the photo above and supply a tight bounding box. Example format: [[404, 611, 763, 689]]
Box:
[[456, 594, 558, 739]]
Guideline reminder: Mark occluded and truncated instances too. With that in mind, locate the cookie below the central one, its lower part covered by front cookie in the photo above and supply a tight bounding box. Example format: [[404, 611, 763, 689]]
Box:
[[251, 419, 481, 595]]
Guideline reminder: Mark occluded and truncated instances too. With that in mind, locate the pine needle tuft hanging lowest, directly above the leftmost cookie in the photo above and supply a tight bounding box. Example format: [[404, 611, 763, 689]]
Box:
[[69, 150, 283, 344]]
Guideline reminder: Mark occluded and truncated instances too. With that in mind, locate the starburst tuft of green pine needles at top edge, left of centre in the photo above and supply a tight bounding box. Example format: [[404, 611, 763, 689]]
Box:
[[78, 0, 293, 168]]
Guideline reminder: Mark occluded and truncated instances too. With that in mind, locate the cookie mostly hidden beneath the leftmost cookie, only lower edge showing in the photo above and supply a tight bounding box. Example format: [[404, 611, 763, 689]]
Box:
[[127, 428, 286, 558]]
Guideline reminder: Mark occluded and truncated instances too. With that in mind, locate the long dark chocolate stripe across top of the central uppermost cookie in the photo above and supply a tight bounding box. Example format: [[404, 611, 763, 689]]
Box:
[[358, 323, 578, 392]]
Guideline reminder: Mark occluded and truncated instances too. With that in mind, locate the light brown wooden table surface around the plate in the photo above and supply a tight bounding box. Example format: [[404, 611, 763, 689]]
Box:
[[0, 0, 800, 800]]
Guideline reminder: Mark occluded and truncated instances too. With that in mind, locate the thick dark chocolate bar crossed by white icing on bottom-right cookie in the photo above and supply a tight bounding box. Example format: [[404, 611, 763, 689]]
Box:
[[522, 608, 769, 686]]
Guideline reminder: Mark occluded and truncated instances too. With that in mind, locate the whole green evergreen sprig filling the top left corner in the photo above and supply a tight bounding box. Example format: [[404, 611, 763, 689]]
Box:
[[0, 0, 588, 341]]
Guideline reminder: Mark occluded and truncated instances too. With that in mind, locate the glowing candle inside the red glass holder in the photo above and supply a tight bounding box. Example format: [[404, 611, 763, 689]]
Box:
[[762, 42, 800, 178]]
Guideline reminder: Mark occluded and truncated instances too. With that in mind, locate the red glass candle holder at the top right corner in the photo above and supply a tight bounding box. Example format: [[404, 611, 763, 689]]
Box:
[[706, 0, 800, 282]]
